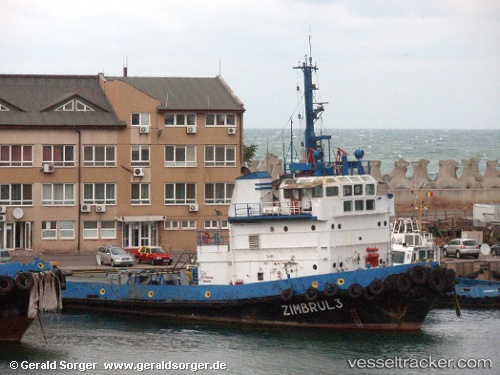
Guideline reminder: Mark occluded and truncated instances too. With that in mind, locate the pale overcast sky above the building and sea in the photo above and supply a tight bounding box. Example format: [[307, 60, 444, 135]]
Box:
[[0, 0, 500, 129]]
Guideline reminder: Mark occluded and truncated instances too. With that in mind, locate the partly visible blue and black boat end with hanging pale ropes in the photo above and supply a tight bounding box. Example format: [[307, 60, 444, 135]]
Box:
[[0, 259, 65, 342]]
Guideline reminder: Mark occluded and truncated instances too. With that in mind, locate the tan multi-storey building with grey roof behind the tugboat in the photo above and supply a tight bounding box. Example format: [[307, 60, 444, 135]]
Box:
[[0, 75, 244, 253]]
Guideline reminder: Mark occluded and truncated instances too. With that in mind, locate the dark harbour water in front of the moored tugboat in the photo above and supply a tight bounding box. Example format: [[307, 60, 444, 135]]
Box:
[[0, 309, 500, 375]]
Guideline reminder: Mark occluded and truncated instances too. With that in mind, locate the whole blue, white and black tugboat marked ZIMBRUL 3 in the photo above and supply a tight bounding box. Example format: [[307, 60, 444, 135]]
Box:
[[63, 57, 455, 330]]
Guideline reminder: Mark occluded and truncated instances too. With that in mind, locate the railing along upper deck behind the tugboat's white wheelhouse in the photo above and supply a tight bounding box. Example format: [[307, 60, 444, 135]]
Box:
[[234, 201, 311, 218]]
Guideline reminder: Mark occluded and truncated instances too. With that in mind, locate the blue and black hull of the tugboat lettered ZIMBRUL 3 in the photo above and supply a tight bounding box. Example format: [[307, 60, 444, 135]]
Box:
[[63, 264, 451, 330]]
